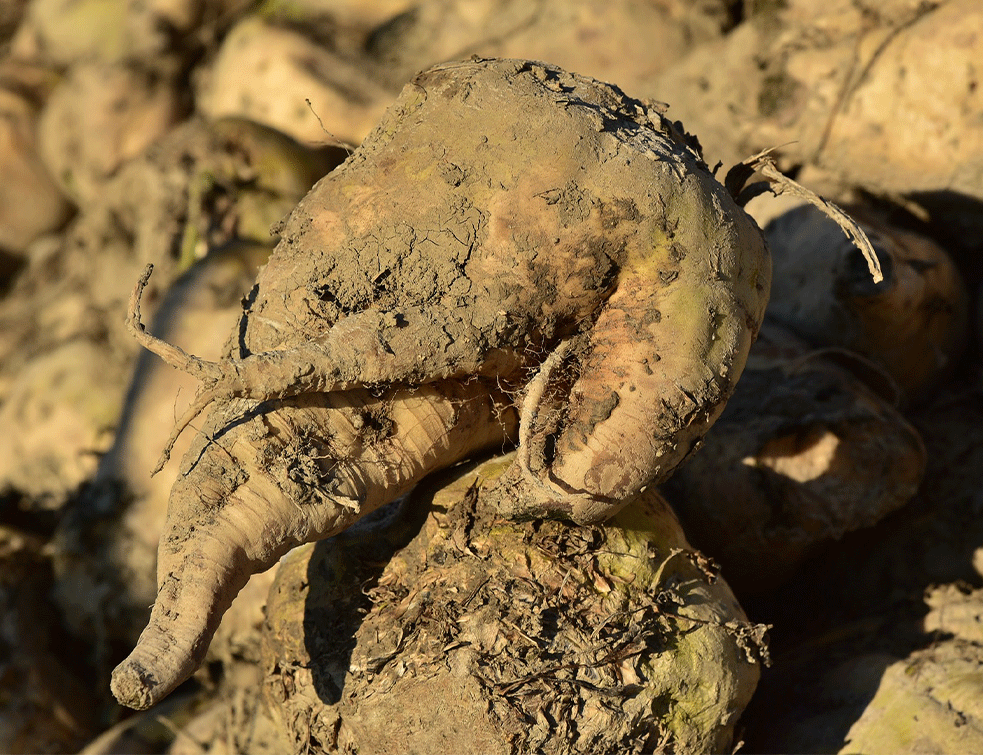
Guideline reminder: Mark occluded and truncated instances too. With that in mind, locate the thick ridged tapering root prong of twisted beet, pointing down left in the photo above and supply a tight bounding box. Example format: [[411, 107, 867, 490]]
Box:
[[112, 381, 516, 709]]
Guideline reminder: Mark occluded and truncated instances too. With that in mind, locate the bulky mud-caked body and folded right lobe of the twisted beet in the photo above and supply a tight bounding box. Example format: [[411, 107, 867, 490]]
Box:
[[240, 60, 770, 516]]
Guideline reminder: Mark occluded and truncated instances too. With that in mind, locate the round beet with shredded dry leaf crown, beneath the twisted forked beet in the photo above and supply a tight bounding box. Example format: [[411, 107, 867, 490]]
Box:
[[263, 458, 762, 755]]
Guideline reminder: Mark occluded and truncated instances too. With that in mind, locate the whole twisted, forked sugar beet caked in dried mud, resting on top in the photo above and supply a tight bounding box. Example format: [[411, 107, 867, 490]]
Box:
[[114, 60, 770, 706]]
